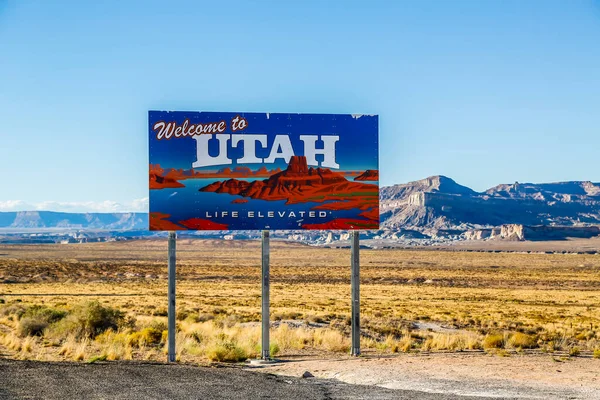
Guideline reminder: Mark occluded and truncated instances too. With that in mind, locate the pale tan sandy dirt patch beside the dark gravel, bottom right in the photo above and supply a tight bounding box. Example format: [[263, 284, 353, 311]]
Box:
[[251, 353, 600, 399]]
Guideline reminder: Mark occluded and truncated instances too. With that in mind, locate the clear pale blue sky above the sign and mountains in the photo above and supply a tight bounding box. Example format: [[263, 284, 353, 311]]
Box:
[[0, 0, 600, 210]]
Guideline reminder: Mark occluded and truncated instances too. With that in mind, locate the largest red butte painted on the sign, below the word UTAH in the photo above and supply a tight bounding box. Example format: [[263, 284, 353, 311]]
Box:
[[200, 156, 378, 216]]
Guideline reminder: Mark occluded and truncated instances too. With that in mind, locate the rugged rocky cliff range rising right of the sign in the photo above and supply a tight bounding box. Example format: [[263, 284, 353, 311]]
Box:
[[380, 176, 600, 237]]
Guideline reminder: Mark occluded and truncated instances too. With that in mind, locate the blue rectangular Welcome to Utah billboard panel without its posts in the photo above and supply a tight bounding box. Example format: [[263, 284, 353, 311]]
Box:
[[148, 111, 379, 230]]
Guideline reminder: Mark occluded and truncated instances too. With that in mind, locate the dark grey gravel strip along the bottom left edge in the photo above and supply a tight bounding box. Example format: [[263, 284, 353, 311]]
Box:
[[0, 359, 480, 400]]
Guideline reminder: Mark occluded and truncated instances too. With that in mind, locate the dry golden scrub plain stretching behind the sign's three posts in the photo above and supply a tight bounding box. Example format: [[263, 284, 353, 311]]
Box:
[[0, 239, 600, 362]]
